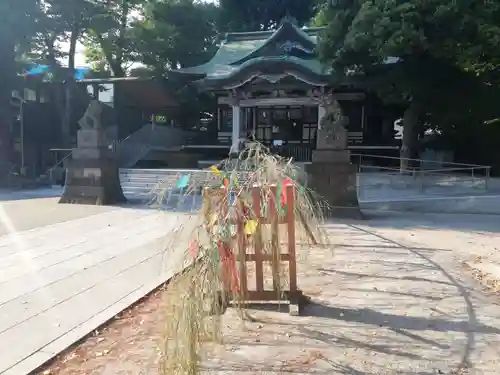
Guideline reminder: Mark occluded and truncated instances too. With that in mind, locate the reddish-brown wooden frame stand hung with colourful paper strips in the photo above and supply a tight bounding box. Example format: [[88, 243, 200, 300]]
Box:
[[204, 185, 307, 315]]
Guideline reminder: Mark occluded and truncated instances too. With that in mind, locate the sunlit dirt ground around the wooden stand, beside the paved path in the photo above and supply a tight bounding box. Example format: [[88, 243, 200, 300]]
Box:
[[40, 216, 500, 375]]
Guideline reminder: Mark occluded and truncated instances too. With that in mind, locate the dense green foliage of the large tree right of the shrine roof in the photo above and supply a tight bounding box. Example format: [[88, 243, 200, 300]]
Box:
[[316, 0, 500, 97]]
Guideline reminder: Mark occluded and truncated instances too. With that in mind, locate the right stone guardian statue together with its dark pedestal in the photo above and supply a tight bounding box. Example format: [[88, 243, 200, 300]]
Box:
[[306, 98, 362, 219]]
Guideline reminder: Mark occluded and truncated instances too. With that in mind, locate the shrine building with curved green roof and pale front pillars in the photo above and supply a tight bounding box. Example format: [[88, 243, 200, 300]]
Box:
[[173, 18, 398, 162]]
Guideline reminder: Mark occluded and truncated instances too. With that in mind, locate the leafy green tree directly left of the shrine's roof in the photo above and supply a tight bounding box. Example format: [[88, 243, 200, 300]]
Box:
[[133, 0, 217, 74]]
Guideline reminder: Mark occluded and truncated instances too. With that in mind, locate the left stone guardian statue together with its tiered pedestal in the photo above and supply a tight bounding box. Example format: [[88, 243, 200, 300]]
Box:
[[59, 100, 127, 205]]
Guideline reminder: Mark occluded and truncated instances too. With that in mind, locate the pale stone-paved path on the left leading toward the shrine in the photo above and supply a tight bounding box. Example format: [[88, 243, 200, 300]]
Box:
[[0, 199, 191, 375]]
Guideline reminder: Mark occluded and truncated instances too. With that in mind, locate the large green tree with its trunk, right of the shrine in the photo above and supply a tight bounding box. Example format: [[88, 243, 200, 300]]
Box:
[[315, 0, 500, 168]]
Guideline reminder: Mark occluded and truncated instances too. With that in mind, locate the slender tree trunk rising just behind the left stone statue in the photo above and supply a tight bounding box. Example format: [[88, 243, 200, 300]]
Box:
[[62, 27, 80, 148]]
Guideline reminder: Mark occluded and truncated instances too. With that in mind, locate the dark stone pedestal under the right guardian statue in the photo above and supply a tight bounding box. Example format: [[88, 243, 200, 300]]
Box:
[[306, 150, 363, 219]]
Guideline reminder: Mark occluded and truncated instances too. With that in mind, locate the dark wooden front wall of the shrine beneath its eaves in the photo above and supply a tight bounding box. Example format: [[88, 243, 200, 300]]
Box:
[[217, 92, 382, 161]]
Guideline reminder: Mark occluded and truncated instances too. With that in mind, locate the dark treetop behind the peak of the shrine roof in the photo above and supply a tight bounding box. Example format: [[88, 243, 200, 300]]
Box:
[[219, 0, 316, 31]]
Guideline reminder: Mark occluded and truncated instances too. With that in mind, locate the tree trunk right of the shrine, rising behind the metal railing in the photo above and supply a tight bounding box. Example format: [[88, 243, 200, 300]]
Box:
[[400, 99, 421, 172]]
